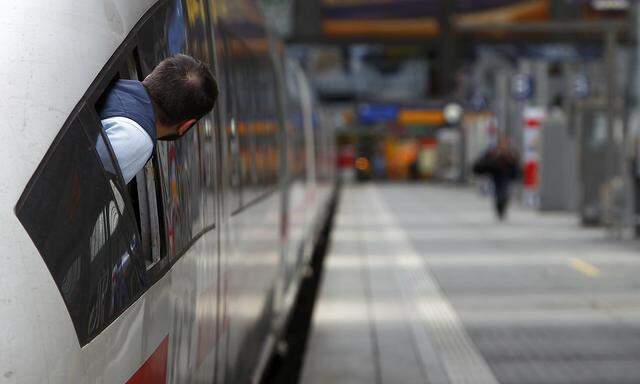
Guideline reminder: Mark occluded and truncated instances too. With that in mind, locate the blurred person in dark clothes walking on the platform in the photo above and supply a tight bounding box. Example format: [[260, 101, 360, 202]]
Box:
[[473, 136, 522, 220]]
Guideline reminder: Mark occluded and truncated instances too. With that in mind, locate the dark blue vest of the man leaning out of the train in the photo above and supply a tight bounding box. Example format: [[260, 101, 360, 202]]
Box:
[[99, 80, 158, 148]]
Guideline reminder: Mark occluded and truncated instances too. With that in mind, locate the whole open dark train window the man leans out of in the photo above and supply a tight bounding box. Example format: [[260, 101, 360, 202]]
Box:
[[16, 41, 175, 345]]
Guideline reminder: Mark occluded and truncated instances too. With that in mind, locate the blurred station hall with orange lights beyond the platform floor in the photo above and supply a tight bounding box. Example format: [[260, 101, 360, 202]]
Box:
[[262, 0, 640, 233]]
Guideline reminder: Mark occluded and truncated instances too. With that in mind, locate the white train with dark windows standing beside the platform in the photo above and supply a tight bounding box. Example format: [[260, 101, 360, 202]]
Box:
[[0, 0, 337, 384]]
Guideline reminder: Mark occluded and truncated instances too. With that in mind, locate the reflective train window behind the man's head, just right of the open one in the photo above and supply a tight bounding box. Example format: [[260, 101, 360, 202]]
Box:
[[138, 0, 215, 259]]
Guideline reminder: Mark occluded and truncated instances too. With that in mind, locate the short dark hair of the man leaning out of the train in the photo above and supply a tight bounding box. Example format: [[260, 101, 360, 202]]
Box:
[[142, 54, 218, 125]]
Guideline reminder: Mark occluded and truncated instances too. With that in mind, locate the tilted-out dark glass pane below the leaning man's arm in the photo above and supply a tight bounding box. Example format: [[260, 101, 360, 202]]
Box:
[[16, 109, 145, 345]]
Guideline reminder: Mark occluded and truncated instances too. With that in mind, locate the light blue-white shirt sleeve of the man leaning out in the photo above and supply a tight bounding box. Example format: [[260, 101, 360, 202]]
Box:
[[102, 117, 153, 184]]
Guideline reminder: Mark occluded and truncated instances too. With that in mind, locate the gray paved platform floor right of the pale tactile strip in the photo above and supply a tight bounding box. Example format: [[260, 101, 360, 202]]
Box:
[[383, 184, 640, 383]]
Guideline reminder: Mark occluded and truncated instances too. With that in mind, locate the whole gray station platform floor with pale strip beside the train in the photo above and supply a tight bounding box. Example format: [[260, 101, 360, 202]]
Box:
[[300, 184, 640, 384]]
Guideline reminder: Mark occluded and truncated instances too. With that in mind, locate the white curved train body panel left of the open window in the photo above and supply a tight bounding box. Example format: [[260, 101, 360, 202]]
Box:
[[0, 1, 162, 383]]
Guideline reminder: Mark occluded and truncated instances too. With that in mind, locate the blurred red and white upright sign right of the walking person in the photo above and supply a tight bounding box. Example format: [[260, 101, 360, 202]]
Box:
[[522, 107, 546, 206]]
